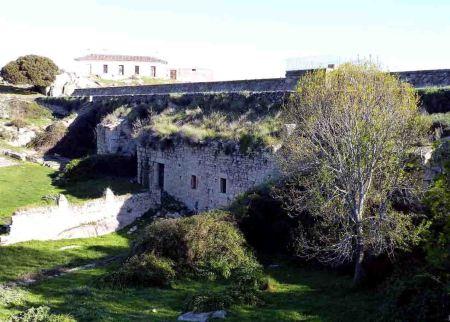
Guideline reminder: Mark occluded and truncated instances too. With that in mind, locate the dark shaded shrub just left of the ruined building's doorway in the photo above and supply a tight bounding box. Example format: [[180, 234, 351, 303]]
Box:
[[61, 154, 136, 181]]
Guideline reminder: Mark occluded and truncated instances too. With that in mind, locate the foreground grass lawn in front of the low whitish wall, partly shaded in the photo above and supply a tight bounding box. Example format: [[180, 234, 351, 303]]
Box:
[[0, 228, 379, 322]]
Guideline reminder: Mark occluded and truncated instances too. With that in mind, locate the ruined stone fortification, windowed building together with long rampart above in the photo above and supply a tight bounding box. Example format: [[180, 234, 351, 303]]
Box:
[[74, 70, 450, 211]]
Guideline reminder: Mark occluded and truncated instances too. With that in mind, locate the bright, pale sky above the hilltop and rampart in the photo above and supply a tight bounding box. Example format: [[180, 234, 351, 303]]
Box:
[[0, 0, 450, 80]]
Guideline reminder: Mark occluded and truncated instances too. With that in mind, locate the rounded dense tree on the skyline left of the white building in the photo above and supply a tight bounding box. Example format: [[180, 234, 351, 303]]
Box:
[[0, 55, 59, 92]]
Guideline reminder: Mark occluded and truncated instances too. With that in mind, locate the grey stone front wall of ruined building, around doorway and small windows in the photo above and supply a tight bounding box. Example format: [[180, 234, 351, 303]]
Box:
[[137, 142, 278, 211]]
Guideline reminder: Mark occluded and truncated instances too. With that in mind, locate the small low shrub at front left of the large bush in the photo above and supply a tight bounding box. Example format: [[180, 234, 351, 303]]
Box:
[[102, 253, 175, 288]]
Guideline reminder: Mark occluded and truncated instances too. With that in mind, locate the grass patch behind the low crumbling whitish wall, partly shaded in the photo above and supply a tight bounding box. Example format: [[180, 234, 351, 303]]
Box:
[[0, 162, 142, 223]]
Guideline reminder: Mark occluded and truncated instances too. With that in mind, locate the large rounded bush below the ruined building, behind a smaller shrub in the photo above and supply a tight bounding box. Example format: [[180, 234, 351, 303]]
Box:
[[133, 211, 257, 279]]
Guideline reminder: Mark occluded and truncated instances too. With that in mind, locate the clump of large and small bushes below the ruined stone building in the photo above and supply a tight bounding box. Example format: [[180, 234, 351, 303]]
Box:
[[100, 211, 259, 287]]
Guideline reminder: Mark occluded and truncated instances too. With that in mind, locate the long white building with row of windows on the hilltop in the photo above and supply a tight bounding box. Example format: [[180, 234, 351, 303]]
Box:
[[75, 54, 169, 79]]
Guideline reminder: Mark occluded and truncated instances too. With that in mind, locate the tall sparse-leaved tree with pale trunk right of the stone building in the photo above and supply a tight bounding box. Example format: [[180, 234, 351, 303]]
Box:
[[278, 64, 426, 284]]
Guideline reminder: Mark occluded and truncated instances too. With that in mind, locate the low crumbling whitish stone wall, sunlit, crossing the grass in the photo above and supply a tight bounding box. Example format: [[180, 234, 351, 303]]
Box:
[[0, 189, 153, 244]]
